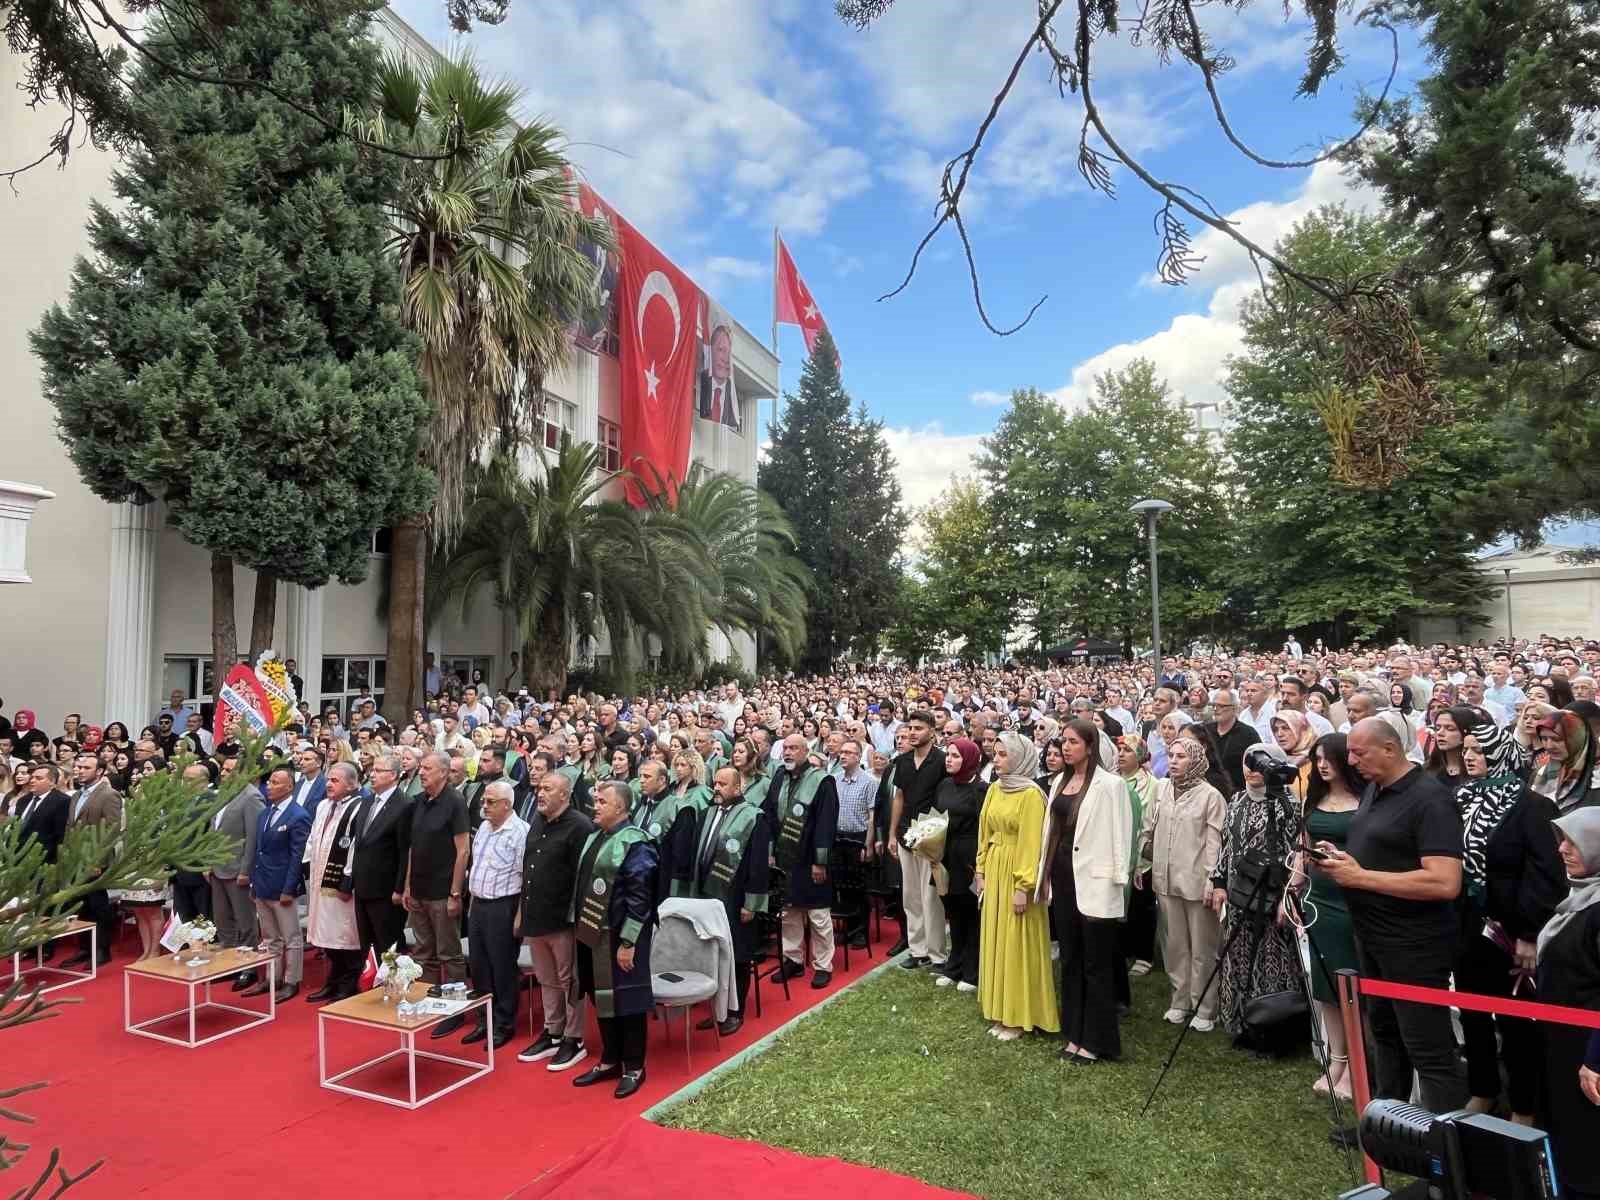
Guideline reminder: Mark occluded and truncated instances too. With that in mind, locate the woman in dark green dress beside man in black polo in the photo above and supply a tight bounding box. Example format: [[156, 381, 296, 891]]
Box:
[[1296, 733, 1366, 1099]]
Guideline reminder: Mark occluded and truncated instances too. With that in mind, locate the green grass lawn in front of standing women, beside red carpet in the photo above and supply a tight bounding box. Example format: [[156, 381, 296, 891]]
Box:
[[662, 966, 1358, 1200]]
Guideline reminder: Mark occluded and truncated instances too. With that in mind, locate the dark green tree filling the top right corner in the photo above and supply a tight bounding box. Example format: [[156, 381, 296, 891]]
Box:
[[1354, 0, 1600, 539]]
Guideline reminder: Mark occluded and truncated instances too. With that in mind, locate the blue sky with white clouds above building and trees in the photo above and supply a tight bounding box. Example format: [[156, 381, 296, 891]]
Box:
[[394, 0, 1424, 502]]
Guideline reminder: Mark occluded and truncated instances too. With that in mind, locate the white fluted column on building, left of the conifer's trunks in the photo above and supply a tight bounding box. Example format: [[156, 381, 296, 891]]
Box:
[[101, 504, 160, 730]]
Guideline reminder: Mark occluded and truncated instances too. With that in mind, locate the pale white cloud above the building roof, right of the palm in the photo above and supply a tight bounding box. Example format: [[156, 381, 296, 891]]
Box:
[[395, 0, 869, 243]]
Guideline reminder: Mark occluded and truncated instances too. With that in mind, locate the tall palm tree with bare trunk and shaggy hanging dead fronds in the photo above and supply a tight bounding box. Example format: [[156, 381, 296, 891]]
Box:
[[354, 56, 613, 720]]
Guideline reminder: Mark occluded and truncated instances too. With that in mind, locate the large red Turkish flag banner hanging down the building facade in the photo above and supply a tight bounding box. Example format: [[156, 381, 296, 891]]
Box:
[[618, 219, 699, 507]]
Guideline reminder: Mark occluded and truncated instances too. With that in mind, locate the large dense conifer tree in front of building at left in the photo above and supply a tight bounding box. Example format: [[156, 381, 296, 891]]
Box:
[[32, 0, 432, 678]]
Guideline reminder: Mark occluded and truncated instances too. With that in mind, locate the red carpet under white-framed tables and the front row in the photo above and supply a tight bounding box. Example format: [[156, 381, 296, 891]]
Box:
[[0, 922, 896, 1200]]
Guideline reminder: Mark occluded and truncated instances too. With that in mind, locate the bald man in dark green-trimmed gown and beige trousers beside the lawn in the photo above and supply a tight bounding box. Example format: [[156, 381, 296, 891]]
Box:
[[762, 733, 838, 989]]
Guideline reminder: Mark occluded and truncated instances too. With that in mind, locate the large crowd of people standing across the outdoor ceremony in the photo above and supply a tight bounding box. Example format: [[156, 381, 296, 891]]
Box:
[[9, 638, 1600, 1194]]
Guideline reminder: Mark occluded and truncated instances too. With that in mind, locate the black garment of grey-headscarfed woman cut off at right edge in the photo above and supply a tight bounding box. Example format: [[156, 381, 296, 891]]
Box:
[[1538, 904, 1600, 1195]]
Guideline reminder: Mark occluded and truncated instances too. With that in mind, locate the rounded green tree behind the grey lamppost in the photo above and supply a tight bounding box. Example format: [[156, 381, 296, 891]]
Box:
[[979, 371, 1229, 650]]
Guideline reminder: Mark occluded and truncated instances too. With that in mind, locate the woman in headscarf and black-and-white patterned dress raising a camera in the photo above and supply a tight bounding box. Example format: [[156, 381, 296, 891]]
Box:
[[1211, 748, 1309, 1035]]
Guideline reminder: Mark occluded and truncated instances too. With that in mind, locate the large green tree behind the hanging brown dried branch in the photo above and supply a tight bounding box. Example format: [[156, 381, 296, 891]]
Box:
[[1227, 208, 1514, 645]]
